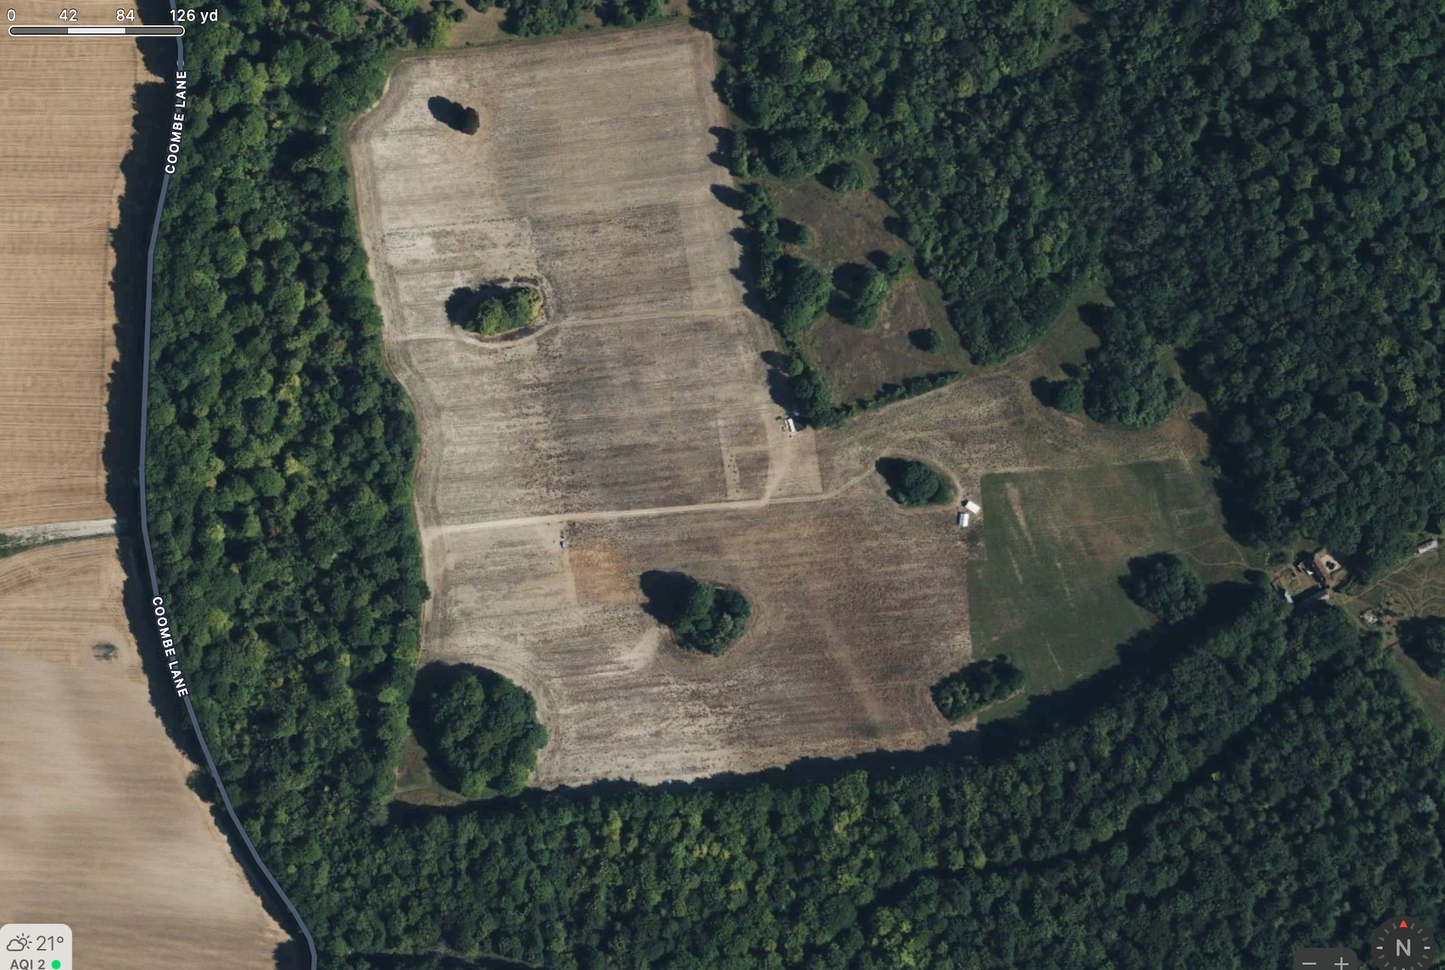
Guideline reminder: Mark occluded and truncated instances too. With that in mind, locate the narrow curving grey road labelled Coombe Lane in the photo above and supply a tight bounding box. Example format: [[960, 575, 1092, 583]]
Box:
[[139, 13, 318, 970]]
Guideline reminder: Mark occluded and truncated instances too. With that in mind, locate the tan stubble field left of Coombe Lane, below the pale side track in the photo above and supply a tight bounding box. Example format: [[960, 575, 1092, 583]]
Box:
[[0, 538, 286, 970]]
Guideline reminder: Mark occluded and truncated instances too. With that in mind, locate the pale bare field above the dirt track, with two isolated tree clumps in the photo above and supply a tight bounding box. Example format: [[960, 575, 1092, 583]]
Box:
[[353, 26, 780, 523]]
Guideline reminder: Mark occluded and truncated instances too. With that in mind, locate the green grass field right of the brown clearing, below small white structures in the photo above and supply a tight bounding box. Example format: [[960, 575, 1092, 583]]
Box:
[[968, 461, 1246, 702]]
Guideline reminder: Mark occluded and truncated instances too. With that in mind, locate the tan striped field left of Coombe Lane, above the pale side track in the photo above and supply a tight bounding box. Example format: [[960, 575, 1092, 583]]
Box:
[[0, 0, 153, 532]]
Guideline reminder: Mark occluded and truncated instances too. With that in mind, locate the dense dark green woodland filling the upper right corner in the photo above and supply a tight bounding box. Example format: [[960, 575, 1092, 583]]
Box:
[[694, 0, 1445, 575]]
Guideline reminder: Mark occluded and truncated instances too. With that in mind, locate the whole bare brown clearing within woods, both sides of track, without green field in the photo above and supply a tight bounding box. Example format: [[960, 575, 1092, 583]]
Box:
[[351, 26, 1231, 801]]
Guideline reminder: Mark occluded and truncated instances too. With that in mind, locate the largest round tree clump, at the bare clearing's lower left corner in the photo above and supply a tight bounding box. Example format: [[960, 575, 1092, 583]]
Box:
[[413, 666, 546, 798]]
